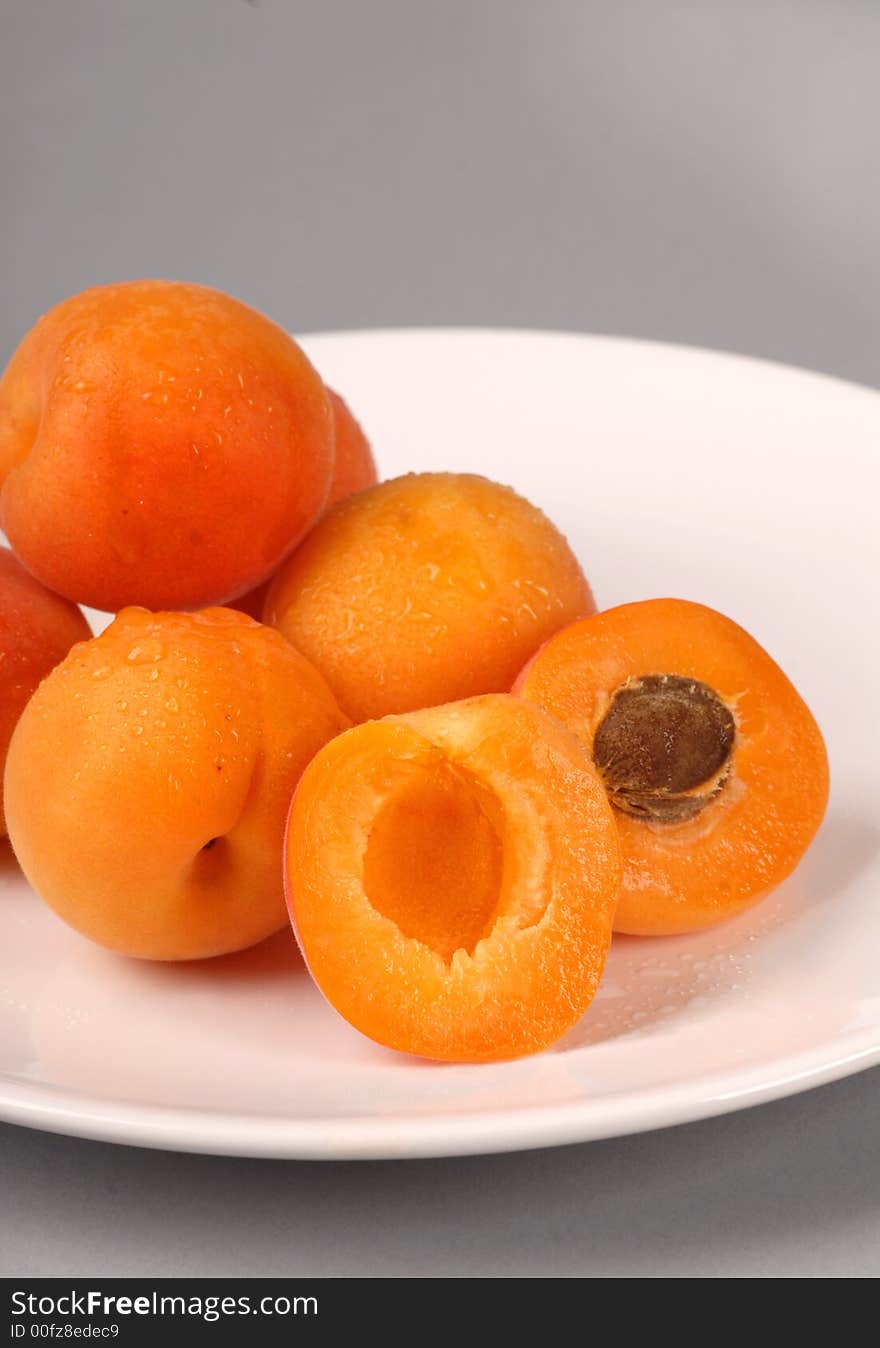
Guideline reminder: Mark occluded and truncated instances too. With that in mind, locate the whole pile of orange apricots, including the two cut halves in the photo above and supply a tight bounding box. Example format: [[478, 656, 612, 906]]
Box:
[[0, 280, 827, 1062]]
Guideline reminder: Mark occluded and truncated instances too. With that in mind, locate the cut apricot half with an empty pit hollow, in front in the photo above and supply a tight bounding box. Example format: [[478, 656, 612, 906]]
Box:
[[284, 694, 620, 1062]]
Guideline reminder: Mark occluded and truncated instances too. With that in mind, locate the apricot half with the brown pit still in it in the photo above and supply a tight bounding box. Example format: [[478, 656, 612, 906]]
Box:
[[513, 599, 829, 936]]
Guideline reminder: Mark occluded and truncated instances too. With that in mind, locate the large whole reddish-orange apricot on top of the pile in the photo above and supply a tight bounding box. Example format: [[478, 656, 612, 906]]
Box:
[[0, 280, 333, 611]]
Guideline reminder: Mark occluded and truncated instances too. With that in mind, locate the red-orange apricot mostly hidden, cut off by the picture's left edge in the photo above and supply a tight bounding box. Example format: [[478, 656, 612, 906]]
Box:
[[0, 547, 92, 836]]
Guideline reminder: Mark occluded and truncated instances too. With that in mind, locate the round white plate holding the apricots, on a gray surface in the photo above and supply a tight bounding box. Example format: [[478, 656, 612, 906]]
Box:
[[0, 330, 880, 1158]]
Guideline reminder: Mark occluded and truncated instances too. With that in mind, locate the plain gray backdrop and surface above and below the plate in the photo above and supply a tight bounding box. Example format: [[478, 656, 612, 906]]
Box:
[[0, 0, 880, 1277]]
